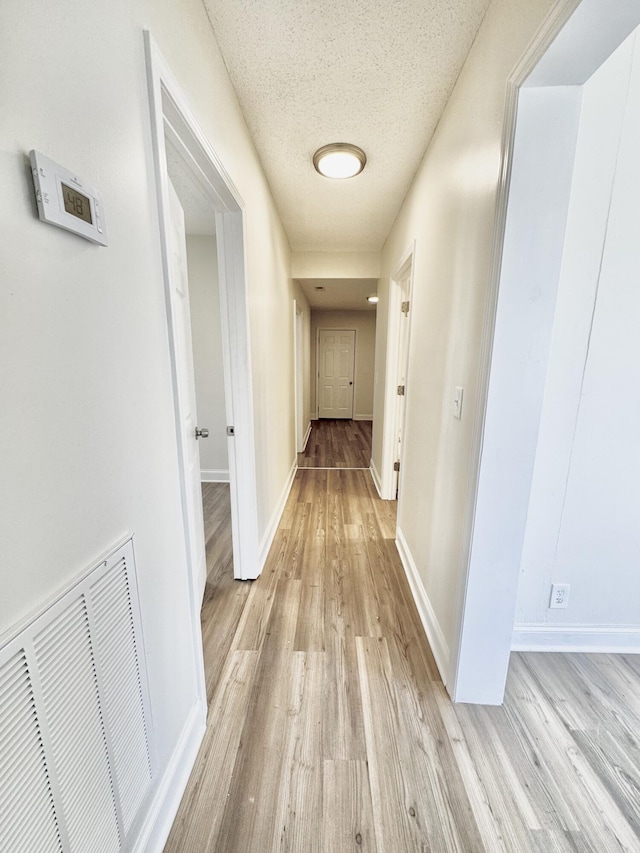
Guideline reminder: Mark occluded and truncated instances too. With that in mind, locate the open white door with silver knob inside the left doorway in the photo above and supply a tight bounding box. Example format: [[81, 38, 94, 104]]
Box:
[[169, 182, 207, 600]]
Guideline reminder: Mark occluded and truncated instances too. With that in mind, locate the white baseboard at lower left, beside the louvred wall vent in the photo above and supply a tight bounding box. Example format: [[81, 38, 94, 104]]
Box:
[[130, 702, 206, 853]]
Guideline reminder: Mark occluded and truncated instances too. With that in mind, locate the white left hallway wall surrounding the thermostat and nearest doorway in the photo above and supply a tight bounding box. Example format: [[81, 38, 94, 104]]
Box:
[[0, 0, 295, 840]]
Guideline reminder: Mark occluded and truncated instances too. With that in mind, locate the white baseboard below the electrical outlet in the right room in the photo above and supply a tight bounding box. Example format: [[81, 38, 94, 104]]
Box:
[[511, 624, 640, 654]]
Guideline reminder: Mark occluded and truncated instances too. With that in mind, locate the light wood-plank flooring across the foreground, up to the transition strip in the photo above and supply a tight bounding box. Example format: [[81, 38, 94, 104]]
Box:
[[166, 470, 640, 853]]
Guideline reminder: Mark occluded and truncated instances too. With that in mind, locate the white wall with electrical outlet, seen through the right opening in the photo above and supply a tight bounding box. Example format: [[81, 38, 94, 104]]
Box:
[[514, 35, 640, 647]]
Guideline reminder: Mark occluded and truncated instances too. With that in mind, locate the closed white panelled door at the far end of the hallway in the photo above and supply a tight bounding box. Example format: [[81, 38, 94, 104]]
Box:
[[318, 329, 356, 418]]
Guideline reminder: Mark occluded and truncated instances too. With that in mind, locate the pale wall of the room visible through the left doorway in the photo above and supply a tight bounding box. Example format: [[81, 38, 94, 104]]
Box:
[[187, 235, 229, 482]]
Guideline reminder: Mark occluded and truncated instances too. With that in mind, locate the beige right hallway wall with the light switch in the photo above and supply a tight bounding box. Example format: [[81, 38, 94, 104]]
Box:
[[373, 0, 553, 668]]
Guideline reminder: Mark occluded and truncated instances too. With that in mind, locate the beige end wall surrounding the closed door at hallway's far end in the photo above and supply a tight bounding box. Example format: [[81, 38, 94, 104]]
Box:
[[311, 310, 376, 420]]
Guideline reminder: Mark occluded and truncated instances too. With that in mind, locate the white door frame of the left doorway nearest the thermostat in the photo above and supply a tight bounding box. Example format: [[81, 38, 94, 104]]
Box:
[[144, 38, 260, 604]]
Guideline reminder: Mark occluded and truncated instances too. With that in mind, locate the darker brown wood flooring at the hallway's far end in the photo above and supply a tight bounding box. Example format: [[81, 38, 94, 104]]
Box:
[[298, 418, 371, 468]]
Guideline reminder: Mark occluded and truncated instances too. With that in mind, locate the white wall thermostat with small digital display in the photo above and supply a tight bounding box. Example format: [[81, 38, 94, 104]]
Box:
[[29, 151, 107, 246]]
